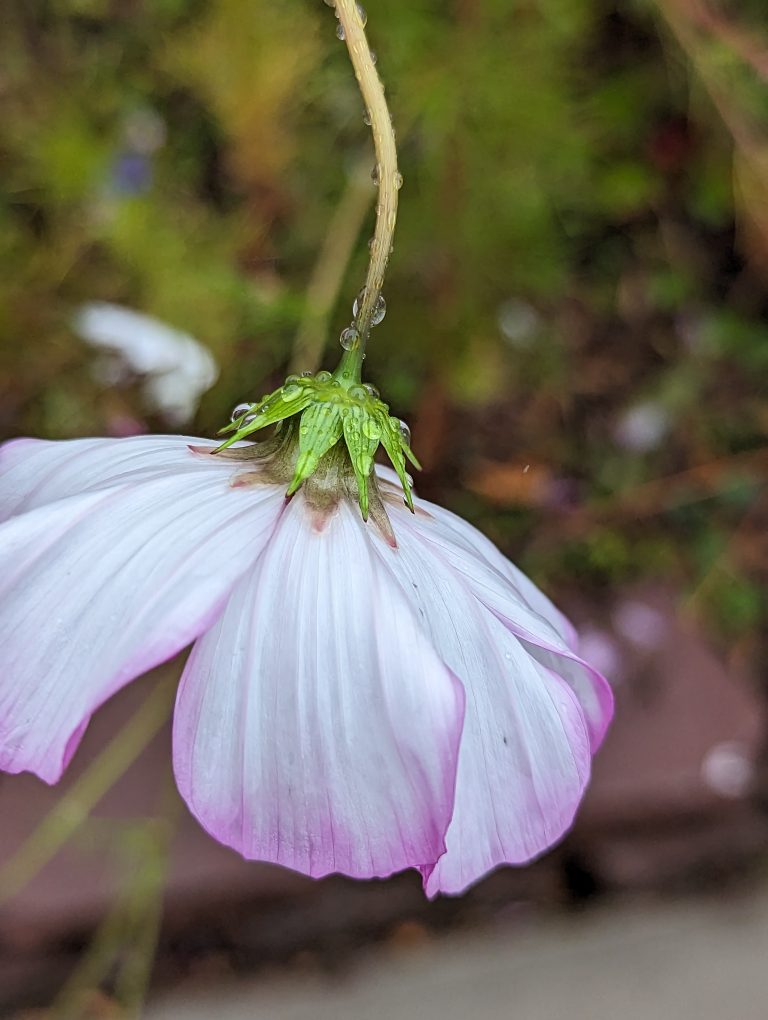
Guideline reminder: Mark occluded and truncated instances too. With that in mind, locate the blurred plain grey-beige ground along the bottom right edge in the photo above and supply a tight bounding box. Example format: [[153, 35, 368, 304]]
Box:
[[147, 889, 768, 1020]]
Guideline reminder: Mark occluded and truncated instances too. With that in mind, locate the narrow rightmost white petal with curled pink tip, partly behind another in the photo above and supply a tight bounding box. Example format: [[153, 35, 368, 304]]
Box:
[[391, 500, 613, 753]]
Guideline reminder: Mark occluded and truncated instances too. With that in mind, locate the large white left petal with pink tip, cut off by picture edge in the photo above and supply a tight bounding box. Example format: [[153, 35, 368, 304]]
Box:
[[0, 452, 285, 782]]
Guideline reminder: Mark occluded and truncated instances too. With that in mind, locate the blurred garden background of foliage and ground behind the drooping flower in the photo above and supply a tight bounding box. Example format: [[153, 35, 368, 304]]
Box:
[[0, 0, 768, 1020]]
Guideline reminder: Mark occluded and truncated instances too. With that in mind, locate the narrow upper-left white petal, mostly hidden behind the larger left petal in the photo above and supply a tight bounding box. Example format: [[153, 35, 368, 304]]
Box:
[[0, 436, 236, 521]]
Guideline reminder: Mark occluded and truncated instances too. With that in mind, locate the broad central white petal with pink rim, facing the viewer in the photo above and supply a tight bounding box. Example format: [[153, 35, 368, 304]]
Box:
[[173, 493, 463, 878]]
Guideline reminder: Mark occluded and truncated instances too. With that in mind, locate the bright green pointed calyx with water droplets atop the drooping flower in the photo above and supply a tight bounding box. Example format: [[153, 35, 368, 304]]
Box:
[[215, 357, 420, 520]]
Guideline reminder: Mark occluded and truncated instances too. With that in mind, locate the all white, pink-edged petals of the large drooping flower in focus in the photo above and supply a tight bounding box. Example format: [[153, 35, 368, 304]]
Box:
[[0, 436, 612, 896]]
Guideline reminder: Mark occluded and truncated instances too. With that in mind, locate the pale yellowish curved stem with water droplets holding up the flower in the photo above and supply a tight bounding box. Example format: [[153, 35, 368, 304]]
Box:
[[336, 0, 402, 356]]
